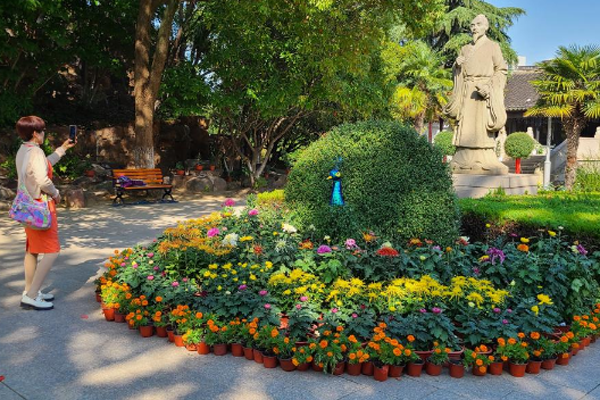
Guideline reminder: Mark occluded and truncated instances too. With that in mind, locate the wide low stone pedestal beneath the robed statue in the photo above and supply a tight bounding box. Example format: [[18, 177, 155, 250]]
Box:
[[452, 174, 541, 198]]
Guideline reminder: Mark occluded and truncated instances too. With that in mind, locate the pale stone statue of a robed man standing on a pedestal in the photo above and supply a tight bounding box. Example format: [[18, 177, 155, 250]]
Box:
[[444, 15, 508, 175]]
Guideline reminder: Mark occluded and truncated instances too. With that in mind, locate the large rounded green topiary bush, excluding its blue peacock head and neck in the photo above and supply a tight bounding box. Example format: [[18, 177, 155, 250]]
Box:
[[285, 121, 459, 244]]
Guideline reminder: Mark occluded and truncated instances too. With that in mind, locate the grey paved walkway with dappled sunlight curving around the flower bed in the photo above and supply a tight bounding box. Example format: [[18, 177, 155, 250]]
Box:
[[0, 198, 600, 400]]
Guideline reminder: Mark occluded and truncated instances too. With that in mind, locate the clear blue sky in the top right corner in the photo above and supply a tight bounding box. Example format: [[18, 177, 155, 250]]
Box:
[[486, 0, 600, 65]]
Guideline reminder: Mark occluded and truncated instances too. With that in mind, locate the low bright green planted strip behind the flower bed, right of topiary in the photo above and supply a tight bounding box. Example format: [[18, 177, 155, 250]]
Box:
[[459, 192, 600, 248]]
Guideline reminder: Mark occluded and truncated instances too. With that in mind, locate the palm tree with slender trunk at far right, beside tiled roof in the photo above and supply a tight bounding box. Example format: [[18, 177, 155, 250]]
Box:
[[525, 45, 600, 190]]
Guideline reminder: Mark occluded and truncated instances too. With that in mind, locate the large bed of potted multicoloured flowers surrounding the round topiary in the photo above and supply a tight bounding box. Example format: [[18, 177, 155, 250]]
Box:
[[97, 200, 600, 380]]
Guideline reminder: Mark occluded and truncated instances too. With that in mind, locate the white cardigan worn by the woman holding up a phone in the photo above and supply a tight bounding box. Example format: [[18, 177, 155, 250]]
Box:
[[15, 142, 66, 199]]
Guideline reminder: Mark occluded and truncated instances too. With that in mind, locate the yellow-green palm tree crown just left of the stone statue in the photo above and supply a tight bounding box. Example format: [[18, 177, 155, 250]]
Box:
[[384, 41, 452, 133]]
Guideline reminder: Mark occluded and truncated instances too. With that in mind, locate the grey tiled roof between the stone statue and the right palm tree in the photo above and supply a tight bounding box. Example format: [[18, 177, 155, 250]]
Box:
[[504, 67, 541, 111]]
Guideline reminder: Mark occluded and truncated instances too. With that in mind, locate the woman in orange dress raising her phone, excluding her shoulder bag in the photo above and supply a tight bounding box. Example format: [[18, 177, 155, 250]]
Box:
[[16, 116, 75, 310]]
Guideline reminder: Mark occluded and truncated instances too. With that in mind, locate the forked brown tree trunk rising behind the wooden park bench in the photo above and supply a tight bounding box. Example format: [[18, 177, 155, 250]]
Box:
[[133, 0, 179, 168]]
